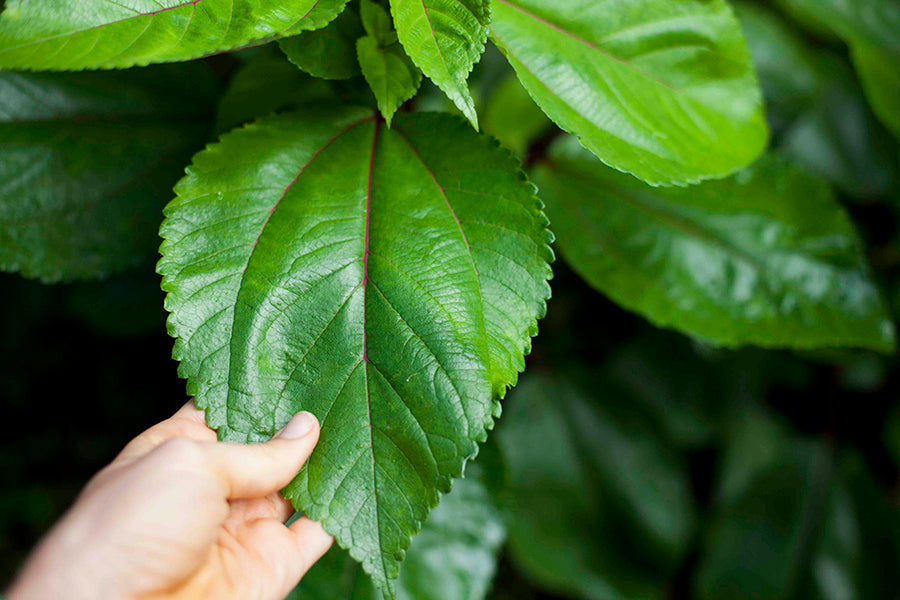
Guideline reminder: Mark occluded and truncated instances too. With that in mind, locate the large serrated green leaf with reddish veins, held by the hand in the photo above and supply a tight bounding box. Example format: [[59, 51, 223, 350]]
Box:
[[159, 109, 552, 595]]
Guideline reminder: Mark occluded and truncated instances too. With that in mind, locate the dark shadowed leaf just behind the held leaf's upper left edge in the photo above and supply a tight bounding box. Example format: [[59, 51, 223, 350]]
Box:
[[215, 46, 342, 134]]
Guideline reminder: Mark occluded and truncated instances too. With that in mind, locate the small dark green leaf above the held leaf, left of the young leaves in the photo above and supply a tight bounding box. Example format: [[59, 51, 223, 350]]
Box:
[[278, 8, 364, 79]]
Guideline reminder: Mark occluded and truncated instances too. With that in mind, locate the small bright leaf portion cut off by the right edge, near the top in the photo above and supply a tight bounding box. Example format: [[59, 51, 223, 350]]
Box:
[[852, 42, 900, 138]]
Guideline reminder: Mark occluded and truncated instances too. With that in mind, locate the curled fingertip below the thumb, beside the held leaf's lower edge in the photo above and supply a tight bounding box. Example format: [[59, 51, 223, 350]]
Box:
[[244, 517, 334, 598]]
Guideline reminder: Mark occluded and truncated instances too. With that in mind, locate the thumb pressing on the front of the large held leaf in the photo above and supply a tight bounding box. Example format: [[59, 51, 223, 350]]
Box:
[[200, 412, 319, 499]]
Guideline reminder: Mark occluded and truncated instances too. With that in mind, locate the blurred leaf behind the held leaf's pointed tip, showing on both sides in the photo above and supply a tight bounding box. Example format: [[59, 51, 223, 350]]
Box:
[[288, 477, 506, 600]]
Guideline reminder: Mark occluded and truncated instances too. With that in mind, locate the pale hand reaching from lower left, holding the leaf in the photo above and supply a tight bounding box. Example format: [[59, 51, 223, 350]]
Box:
[[6, 403, 333, 600]]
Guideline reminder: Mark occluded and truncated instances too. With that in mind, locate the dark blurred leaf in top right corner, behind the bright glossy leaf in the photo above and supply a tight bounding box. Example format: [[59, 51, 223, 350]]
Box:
[[737, 3, 897, 198]]
